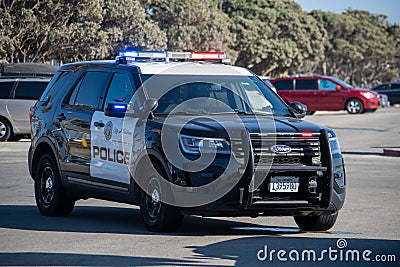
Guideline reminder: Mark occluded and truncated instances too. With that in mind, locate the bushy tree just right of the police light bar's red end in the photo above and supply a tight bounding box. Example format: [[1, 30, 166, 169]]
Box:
[[222, 0, 325, 76]]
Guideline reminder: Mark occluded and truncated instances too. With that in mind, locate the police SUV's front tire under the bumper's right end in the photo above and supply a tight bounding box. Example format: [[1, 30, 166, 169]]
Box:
[[294, 212, 338, 231]]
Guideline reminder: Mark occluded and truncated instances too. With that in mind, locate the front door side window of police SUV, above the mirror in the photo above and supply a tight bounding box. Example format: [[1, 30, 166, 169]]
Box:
[[105, 73, 134, 105]]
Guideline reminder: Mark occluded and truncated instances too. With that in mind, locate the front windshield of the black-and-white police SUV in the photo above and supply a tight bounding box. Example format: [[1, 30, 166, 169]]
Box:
[[142, 74, 292, 116]]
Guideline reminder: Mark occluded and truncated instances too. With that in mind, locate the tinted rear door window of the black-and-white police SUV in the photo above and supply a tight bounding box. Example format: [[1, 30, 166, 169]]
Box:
[[68, 71, 108, 109]]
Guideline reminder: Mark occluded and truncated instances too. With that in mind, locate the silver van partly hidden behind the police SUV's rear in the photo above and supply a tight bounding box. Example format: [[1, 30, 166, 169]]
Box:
[[0, 76, 50, 141]]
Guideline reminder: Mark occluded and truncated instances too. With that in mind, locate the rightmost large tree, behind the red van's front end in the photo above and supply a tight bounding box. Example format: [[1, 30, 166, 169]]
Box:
[[311, 9, 400, 87]]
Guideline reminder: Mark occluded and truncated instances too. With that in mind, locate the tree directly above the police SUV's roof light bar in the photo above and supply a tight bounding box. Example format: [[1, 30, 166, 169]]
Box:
[[147, 0, 234, 57]]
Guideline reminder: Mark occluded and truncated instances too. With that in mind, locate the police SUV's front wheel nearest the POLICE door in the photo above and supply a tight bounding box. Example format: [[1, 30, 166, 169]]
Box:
[[140, 166, 183, 232]]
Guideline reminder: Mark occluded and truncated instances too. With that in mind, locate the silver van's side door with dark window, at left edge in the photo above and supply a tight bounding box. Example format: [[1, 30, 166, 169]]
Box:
[[7, 80, 48, 133]]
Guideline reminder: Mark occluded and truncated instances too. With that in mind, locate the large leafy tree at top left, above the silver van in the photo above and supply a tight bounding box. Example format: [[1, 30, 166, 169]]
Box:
[[0, 0, 166, 62]]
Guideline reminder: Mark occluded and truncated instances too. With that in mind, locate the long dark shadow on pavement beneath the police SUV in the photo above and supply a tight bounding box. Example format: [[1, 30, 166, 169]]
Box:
[[0, 205, 300, 236]]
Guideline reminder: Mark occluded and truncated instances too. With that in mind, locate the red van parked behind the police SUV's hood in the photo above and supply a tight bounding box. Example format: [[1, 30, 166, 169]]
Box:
[[270, 76, 379, 114]]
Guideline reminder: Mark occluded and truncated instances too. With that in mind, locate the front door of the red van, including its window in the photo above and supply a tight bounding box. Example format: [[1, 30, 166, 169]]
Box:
[[317, 79, 346, 110]]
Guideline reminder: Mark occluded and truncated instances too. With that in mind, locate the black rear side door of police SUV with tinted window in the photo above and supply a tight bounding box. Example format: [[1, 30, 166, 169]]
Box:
[[55, 70, 110, 178]]
